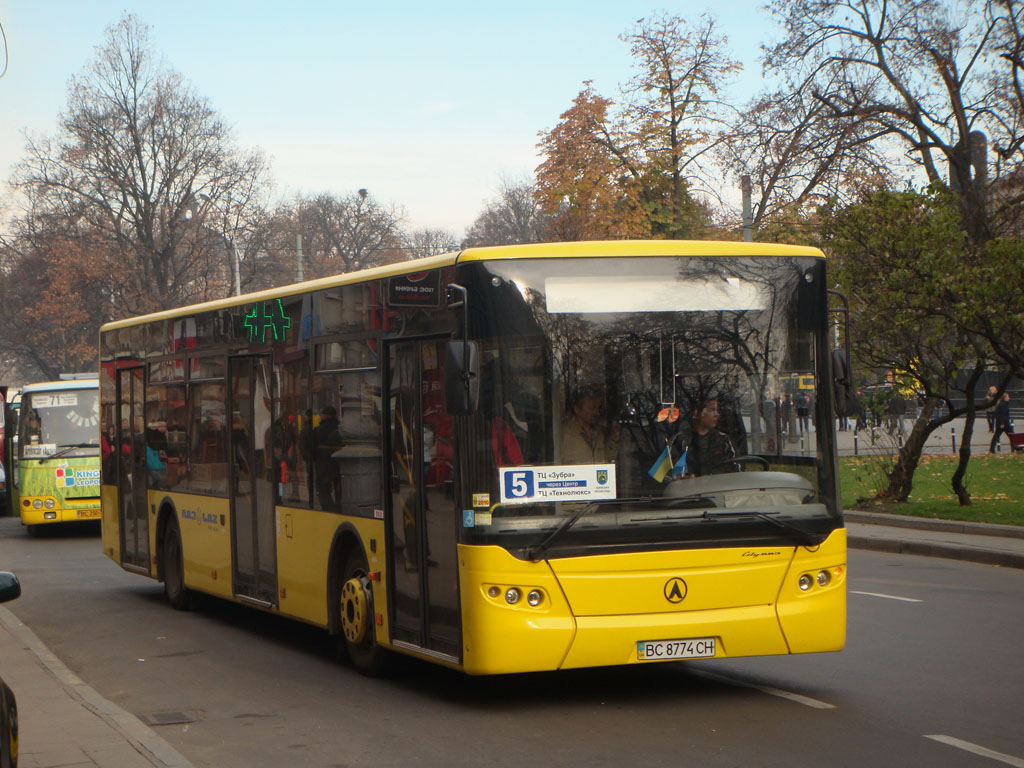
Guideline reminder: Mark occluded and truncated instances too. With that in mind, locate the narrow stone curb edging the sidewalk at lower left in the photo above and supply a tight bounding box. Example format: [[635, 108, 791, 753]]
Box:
[[0, 606, 195, 768]]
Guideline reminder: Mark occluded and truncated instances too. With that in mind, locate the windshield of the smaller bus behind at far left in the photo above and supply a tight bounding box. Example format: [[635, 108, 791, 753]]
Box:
[[18, 387, 99, 459]]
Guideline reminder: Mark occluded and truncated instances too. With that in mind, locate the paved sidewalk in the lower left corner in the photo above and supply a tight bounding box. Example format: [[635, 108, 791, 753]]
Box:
[[0, 607, 193, 768]]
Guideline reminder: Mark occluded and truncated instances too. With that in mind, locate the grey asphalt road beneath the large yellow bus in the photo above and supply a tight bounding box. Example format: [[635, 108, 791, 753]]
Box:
[[0, 518, 1024, 768]]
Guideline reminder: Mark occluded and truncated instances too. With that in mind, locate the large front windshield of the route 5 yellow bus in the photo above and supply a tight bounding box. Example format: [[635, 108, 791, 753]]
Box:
[[460, 257, 842, 559]]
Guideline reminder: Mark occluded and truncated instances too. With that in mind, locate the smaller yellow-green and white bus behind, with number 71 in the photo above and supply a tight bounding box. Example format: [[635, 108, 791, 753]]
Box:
[[10, 374, 100, 534]]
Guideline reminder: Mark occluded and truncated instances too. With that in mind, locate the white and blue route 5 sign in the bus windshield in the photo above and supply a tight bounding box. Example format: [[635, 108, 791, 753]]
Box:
[[498, 464, 615, 504]]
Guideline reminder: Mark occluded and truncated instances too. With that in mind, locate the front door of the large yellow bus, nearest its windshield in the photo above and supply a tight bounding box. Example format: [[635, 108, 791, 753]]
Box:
[[387, 339, 462, 660]]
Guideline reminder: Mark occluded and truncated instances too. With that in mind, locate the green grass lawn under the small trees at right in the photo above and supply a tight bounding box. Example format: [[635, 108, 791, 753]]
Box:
[[840, 454, 1024, 525]]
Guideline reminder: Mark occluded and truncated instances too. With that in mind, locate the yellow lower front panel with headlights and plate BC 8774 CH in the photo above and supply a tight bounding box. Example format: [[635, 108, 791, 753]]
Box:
[[460, 528, 846, 675]]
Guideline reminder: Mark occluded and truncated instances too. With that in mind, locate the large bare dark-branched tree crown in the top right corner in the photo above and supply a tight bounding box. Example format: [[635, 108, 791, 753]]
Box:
[[765, 0, 1024, 243]]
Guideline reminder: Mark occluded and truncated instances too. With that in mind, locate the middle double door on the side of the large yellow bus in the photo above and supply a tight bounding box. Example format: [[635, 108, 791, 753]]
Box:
[[228, 355, 278, 607]]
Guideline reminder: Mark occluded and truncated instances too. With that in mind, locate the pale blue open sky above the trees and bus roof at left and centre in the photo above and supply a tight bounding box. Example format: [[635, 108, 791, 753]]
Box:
[[0, 0, 777, 237]]
